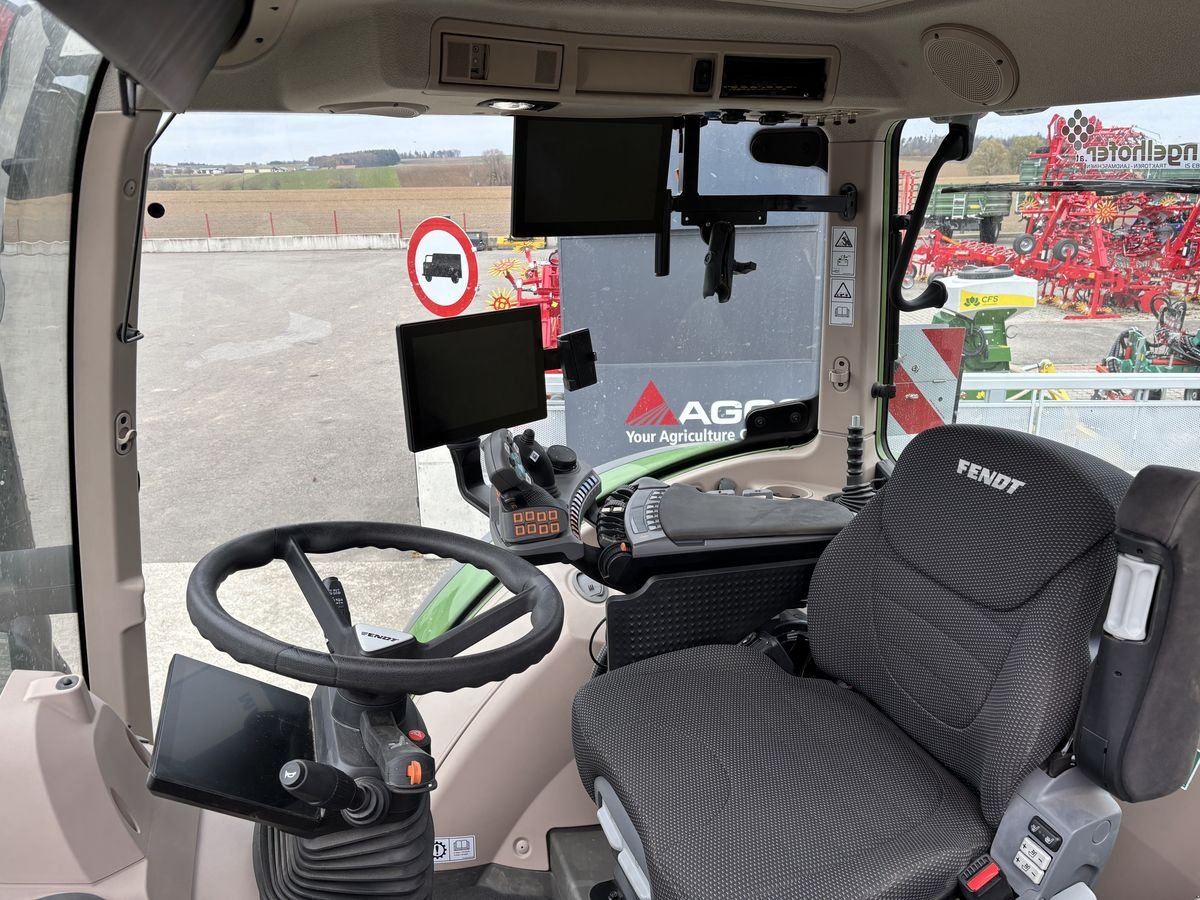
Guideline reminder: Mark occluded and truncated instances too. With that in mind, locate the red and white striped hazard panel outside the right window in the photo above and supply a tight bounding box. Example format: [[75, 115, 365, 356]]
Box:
[[888, 325, 966, 454]]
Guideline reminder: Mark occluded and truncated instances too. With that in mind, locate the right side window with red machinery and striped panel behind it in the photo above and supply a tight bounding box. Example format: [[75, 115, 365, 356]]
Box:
[[887, 97, 1200, 472]]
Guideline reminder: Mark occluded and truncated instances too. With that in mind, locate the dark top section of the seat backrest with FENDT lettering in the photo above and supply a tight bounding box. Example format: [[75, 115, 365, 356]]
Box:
[[878, 425, 1130, 610]]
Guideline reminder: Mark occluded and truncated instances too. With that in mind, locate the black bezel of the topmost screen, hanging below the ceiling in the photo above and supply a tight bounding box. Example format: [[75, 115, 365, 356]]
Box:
[[511, 115, 676, 238]]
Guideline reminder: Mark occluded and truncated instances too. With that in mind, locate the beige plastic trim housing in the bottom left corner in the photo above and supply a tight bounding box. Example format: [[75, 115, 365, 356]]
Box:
[[0, 671, 199, 900]]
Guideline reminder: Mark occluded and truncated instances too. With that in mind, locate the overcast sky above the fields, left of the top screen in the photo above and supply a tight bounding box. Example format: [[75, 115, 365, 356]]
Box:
[[154, 113, 512, 163]]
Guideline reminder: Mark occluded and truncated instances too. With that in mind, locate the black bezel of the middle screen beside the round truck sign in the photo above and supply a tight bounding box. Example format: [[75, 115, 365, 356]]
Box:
[[396, 306, 546, 454]]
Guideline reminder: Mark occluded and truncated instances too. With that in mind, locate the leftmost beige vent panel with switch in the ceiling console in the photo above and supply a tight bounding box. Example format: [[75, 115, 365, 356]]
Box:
[[440, 35, 563, 90]]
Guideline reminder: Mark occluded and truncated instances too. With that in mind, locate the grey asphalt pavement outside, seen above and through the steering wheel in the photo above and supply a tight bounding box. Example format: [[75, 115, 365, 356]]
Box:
[[137, 251, 537, 702]]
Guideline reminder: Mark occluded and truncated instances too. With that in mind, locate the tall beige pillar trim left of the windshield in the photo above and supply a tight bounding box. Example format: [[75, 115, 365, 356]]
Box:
[[72, 77, 161, 734]]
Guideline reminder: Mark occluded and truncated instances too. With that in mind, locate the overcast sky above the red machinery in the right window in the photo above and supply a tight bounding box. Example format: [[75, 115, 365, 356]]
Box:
[[904, 96, 1200, 143]]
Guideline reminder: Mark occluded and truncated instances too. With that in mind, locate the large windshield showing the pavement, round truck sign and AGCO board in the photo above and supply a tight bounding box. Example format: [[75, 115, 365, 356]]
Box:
[[131, 113, 827, 696]]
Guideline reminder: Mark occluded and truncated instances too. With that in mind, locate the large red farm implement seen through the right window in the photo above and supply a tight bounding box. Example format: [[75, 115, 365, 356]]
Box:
[[911, 110, 1200, 318]]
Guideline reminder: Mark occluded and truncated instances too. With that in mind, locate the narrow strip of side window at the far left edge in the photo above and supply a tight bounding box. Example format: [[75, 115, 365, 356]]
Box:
[[0, 7, 100, 686]]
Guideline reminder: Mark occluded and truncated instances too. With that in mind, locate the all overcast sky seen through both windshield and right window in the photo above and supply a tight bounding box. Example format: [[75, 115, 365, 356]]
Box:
[[154, 96, 1200, 163]]
